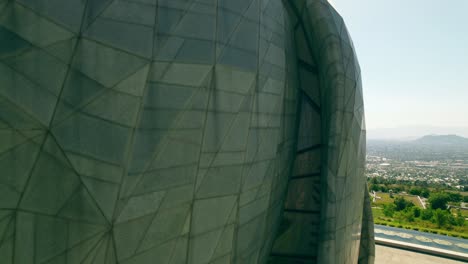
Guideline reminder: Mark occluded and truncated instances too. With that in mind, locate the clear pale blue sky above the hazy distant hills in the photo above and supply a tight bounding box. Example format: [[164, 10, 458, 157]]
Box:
[[330, 0, 468, 129]]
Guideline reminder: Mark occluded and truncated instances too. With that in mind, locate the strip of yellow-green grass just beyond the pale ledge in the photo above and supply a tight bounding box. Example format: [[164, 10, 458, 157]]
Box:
[[372, 208, 468, 239]]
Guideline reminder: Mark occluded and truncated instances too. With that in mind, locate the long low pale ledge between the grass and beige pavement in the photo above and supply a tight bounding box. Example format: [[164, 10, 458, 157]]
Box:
[[375, 237, 468, 262]]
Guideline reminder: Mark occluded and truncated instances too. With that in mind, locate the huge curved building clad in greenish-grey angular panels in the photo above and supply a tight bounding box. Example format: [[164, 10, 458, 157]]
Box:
[[0, 0, 373, 264]]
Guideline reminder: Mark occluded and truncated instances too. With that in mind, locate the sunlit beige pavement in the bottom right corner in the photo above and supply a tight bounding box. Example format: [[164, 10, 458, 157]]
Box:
[[375, 245, 465, 264]]
